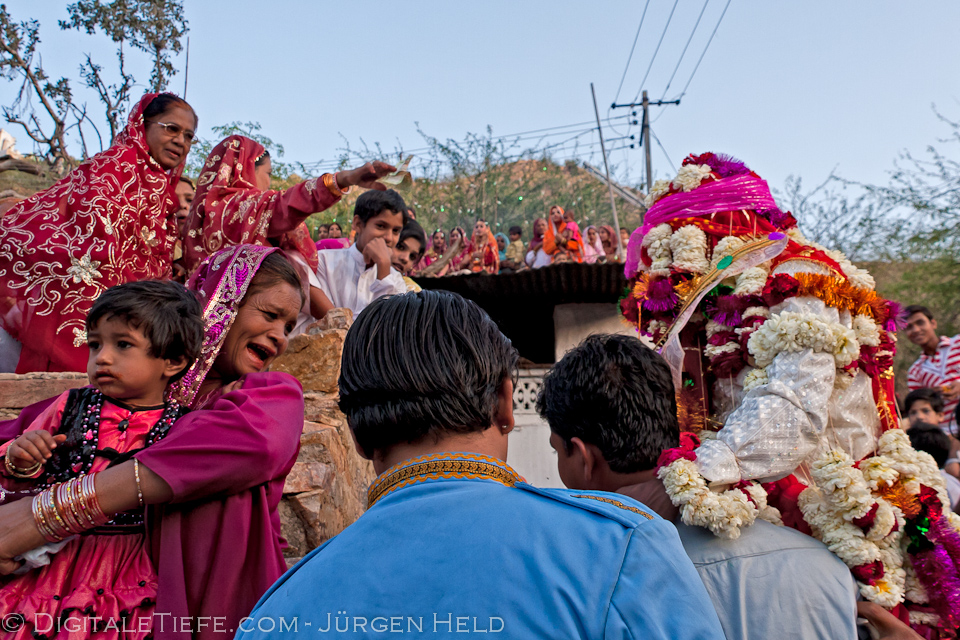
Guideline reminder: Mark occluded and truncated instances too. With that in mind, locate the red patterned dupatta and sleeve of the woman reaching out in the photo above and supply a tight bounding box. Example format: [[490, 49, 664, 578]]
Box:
[[183, 135, 328, 272]]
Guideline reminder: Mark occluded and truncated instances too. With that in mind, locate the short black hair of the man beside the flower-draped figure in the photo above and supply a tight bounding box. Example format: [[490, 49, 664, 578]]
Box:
[[537, 335, 680, 473]]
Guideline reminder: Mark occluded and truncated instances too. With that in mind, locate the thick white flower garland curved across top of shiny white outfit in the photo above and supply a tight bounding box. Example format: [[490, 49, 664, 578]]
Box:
[[747, 311, 860, 369]]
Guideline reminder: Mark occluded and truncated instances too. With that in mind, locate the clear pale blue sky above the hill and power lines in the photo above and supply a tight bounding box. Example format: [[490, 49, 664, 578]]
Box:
[[0, 0, 960, 192]]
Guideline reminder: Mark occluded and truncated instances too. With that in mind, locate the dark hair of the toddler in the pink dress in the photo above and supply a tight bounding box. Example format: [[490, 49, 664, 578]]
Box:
[[86, 280, 203, 380]]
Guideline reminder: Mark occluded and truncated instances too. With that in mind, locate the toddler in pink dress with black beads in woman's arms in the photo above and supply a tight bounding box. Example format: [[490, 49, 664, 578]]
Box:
[[0, 280, 203, 637]]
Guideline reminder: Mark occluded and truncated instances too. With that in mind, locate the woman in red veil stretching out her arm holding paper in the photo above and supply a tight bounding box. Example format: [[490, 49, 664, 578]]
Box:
[[184, 135, 396, 272]]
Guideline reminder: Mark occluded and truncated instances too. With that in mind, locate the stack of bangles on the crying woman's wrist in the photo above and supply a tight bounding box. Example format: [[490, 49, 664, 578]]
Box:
[[33, 473, 110, 542]]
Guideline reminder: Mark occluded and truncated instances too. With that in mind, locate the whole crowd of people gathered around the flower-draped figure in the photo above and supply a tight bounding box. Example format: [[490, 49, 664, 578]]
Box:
[[0, 94, 960, 640]]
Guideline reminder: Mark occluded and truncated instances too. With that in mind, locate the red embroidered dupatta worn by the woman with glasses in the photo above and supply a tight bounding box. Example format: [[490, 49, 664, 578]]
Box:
[[0, 93, 183, 373]]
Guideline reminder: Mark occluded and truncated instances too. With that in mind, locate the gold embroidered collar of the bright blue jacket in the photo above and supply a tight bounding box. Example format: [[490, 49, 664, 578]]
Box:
[[367, 453, 526, 509]]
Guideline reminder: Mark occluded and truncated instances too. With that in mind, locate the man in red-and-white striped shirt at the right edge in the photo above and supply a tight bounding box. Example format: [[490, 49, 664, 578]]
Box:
[[906, 304, 960, 436]]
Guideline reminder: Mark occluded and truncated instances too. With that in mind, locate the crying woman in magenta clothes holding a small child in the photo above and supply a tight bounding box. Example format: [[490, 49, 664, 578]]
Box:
[[0, 245, 304, 640]]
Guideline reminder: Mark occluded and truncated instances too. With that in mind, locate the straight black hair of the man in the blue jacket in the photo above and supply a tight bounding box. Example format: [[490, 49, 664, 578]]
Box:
[[340, 291, 518, 457]]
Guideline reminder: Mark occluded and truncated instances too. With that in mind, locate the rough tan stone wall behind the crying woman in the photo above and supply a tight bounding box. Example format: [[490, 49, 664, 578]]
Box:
[[0, 309, 376, 565]]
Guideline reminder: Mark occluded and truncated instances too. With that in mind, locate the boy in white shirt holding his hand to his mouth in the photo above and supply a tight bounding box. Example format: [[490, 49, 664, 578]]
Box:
[[310, 189, 407, 320]]
